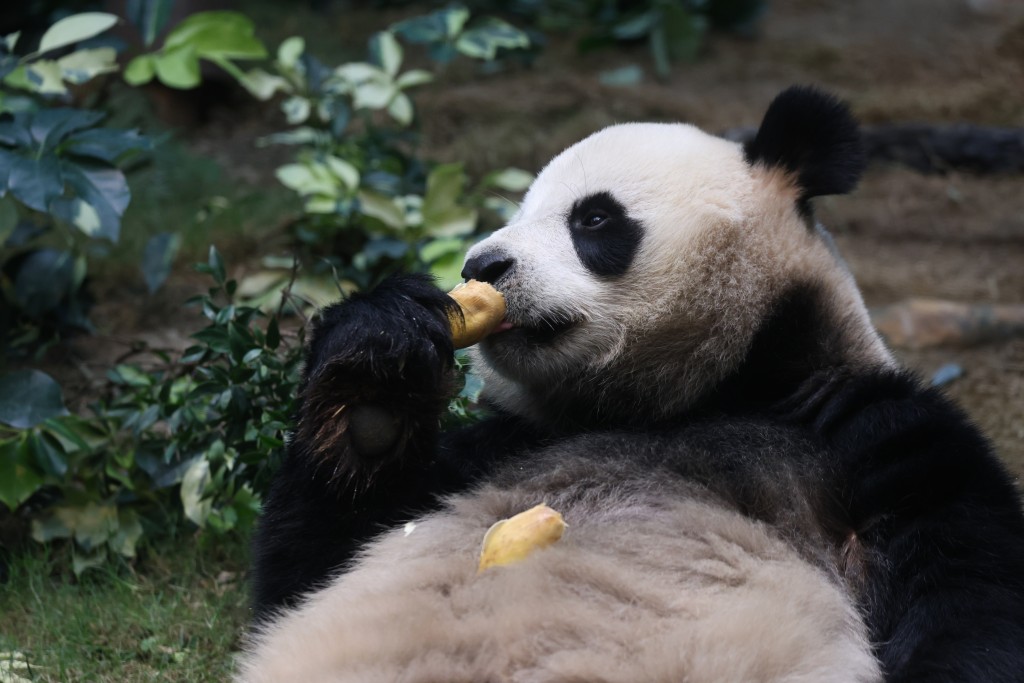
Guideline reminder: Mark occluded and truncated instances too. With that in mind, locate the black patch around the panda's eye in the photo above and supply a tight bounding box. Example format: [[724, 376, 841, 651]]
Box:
[[566, 191, 643, 278]]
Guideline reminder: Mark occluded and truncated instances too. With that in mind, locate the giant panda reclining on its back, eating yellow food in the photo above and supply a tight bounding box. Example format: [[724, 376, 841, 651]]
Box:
[[238, 87, 1024, 683]]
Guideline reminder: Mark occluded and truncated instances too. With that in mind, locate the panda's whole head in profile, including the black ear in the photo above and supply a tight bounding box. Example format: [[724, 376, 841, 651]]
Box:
[[463, 88, 891, 424]]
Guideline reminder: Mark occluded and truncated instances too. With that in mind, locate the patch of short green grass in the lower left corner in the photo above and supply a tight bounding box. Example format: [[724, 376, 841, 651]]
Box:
[[0, 537, 249, 683]]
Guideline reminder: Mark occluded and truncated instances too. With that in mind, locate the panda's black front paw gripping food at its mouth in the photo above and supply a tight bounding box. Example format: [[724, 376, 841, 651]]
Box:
[[295, 274, 457, 480]]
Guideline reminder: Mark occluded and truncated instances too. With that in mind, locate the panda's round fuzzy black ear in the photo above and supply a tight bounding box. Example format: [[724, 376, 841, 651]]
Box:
[[743, 86, 866, 205]]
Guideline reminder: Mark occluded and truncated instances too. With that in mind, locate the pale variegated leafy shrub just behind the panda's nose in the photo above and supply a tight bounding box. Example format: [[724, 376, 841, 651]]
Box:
[[235, 5, 531, 296]]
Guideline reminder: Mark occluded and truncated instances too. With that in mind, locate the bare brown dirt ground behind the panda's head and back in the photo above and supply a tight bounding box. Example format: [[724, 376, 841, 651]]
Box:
[[64, 0, 1024, 474]]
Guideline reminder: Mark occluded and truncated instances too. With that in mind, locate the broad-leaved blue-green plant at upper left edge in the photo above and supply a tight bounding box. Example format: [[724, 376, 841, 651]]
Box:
[[0, 12, 150, 348]]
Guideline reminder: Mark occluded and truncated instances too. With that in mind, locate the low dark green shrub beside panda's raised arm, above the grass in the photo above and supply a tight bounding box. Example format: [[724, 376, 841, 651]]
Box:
[[0, 249, 302, 569]]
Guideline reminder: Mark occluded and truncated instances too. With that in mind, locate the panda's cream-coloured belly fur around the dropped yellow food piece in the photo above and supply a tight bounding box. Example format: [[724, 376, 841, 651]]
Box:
[[239, 473, 881, 683]]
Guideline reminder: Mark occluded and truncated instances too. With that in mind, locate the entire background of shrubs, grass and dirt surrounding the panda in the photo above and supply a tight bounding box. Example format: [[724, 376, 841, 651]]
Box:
[[0, 0, 1024, 681]]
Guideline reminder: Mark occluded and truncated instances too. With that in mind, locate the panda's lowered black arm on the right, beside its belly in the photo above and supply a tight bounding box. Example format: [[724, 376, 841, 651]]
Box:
[[794, 374, 1024, 683]]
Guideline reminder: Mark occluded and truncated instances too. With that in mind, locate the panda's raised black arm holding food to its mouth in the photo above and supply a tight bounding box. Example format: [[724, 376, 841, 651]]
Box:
[[253, 275, 540, 618]]
